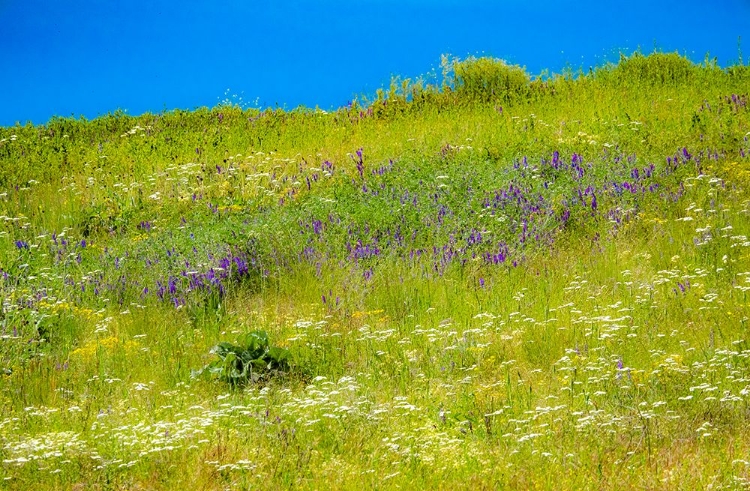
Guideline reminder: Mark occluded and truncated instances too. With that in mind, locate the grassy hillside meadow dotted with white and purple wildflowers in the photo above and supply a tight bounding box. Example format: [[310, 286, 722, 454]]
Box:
[[0, 53, 750, 490]]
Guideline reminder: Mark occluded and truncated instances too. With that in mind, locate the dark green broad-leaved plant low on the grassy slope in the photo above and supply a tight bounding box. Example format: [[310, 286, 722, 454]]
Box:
[[193, 331, 292, 387]]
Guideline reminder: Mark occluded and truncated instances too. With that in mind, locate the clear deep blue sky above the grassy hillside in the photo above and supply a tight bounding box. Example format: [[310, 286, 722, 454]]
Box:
[[0, 0, 750, 126]]
